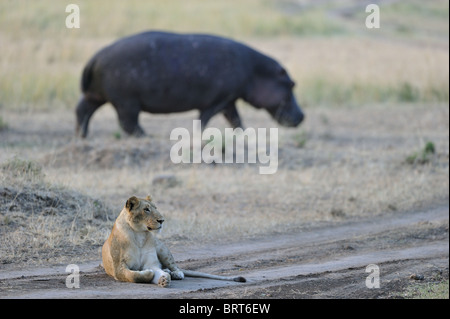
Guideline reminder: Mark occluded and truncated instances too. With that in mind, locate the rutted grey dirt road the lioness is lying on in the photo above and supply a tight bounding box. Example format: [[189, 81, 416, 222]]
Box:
[[0, 205, 449, 298]]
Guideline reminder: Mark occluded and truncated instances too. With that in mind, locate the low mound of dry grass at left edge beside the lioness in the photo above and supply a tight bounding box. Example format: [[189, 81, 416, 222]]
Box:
[[0, 157, 114, 264]]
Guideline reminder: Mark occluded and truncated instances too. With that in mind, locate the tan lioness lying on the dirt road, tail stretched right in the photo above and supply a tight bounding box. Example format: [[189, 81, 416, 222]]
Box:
[[102, 196, 246, 287]]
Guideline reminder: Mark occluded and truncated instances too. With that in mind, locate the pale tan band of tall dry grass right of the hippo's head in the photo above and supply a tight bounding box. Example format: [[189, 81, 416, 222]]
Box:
[[254, 37, 449, 107]]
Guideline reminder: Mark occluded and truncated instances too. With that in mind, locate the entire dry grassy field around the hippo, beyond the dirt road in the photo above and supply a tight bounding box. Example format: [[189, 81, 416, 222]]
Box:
[[0, 0, 449, 298]]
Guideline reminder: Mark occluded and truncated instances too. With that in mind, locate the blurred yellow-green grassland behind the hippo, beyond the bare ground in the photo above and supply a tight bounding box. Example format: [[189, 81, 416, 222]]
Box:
[[0, 0, 449, 110]]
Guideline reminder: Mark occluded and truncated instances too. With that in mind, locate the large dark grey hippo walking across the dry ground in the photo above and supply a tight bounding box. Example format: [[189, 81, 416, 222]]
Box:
[[76, 32, 304, 137]]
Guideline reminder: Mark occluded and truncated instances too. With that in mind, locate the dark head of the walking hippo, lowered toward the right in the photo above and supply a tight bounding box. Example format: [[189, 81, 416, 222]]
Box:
[[244, 59, 304, 127]]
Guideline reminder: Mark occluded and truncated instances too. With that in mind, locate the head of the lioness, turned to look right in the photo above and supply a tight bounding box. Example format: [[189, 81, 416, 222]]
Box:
[[125, 196, 164, 233]]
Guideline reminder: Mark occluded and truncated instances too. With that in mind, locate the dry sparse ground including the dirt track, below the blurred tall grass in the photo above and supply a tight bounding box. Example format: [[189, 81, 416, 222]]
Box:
[[0, 107, 449, 299]]
